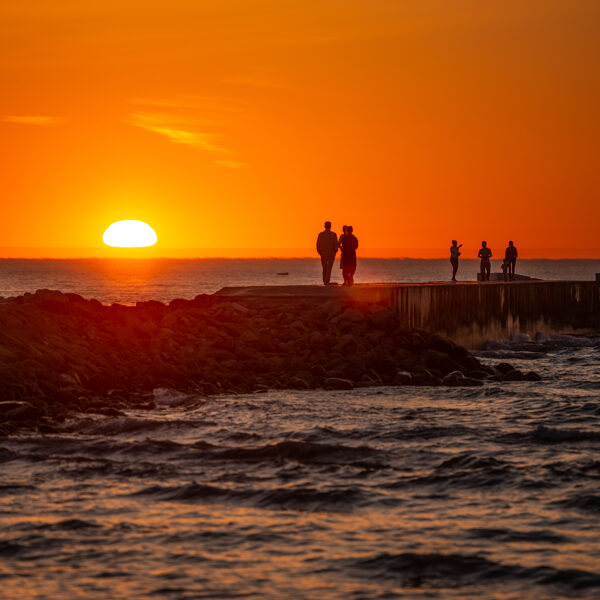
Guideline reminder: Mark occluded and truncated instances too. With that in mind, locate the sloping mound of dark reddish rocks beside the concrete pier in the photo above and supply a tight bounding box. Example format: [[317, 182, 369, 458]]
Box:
[[0, 290, 538, 433]]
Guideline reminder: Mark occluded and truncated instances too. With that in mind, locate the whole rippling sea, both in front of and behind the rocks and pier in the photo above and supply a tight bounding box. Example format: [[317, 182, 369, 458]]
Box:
[[0, 261, 600, 600]]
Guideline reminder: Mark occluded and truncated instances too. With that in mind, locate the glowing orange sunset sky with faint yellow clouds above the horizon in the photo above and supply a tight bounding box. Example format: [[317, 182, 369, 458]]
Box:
[[0, 0, 600, 257]]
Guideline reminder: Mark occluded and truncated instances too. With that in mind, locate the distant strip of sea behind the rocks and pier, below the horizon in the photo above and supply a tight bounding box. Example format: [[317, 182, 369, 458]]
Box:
[[0, 258, 600, 304]]
